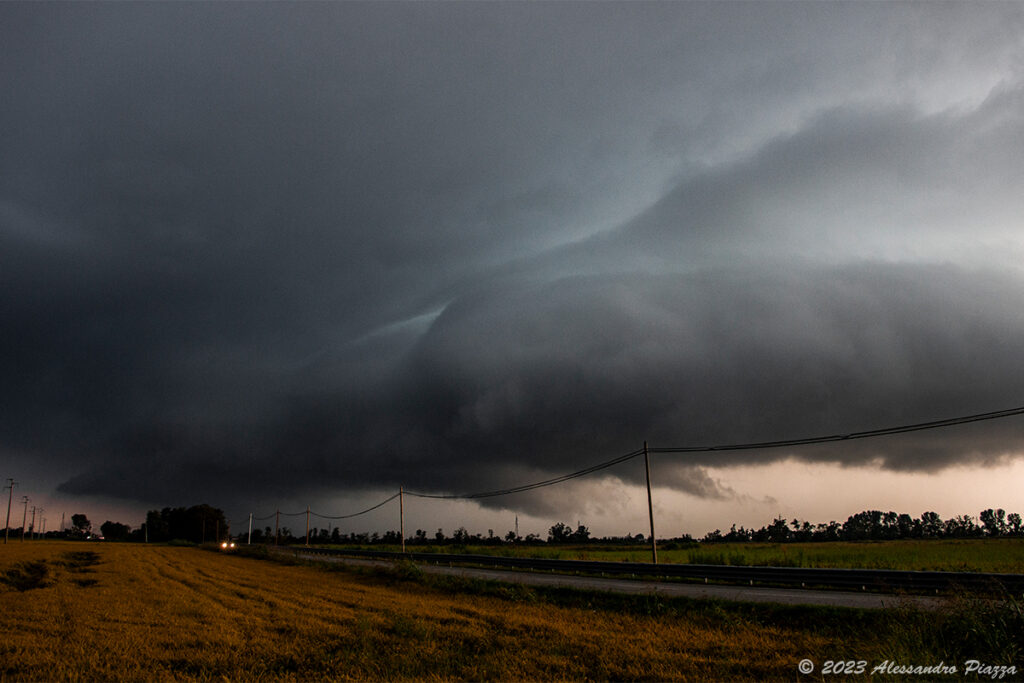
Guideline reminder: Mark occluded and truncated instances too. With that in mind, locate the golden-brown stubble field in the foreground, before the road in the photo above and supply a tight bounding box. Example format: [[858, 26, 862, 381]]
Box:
[[0, 542, 1024, 681]]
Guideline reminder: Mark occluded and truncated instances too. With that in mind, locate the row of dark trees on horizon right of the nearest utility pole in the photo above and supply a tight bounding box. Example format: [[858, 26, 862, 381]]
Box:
[[700, 508, 1024, 543]]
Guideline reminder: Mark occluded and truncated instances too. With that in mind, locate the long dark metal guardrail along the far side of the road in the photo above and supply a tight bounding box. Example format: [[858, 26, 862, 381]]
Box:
[[301, 548, 1024, 595]]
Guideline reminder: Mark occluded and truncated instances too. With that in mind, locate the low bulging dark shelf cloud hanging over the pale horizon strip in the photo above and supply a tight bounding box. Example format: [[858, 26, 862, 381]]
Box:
[[54, 264, 1024, 505]]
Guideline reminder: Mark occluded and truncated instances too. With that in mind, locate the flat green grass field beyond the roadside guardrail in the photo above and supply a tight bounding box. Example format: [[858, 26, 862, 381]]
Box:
[[325, 539, 1024, 573]]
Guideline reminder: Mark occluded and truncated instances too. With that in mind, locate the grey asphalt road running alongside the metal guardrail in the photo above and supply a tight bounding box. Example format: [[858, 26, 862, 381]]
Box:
[[296, 551, 945, 609]]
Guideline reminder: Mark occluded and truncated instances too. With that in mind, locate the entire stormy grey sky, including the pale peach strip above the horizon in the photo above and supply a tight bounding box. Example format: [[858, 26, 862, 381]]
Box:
[[0, 2, 1024, 537]]
